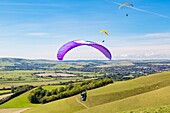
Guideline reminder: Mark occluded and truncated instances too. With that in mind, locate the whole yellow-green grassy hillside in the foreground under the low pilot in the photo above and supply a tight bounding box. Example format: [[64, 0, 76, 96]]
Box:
[[23, 72, 170, 113]]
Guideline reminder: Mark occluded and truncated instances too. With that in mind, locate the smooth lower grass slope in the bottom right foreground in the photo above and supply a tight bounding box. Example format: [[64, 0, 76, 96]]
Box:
[[77, 86, 170, 113]]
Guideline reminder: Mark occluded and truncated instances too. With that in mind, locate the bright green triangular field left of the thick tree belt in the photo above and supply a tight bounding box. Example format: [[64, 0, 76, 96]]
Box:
[[0, 91, 40, 109]]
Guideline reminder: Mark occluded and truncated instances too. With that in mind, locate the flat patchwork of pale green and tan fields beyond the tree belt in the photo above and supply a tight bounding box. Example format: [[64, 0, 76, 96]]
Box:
[[0, 70, 95, 88]]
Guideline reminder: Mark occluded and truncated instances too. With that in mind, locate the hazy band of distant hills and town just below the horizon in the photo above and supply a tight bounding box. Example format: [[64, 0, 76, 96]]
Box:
[[0, 58, 170, 80]]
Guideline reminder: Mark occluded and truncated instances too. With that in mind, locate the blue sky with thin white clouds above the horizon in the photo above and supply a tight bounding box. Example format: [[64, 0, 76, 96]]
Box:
[[0, 0, 170, 60]]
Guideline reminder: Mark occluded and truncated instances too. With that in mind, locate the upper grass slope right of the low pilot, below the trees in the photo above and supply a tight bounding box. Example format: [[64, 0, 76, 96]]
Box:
[[85, 72, 170, 107]]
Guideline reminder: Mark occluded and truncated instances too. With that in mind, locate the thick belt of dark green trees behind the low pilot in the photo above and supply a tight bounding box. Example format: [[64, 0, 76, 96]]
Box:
[[28, 78, 113, 104]]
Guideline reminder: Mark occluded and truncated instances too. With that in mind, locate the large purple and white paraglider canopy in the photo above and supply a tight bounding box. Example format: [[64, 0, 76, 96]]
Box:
[[57, 40, 112, 60]]
